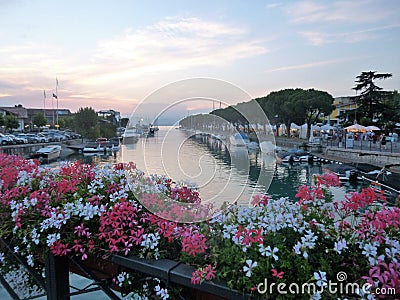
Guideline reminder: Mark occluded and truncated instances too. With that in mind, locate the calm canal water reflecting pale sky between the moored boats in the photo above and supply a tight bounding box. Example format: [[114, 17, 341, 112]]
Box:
[[47, 126, 359, 204]]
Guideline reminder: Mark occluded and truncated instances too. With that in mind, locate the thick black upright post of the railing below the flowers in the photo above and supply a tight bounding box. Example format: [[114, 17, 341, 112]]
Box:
[[46, 253, 70, 300]]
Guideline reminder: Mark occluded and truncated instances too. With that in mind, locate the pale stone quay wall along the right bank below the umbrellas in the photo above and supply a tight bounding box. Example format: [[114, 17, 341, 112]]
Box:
[[323, 147, 400, 167]]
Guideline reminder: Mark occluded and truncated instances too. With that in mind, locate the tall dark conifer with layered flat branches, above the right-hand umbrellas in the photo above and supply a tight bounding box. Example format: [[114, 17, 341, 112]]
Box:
[[353, 71, 392, 121]]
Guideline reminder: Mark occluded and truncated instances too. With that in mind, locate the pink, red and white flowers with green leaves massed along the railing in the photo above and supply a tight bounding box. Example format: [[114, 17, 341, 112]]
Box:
[[0, 155, 400, 299]]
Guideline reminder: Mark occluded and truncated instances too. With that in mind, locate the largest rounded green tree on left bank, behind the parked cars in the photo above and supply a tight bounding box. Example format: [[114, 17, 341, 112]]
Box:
[[74, 107, 100, 140]]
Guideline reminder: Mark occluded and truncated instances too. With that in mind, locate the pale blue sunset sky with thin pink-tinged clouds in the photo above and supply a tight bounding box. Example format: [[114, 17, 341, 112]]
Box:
[[0, 0, 400, 123]]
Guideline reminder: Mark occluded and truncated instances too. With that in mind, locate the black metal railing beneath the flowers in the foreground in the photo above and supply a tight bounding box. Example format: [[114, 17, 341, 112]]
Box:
[[0, 240, 254, 300]]
